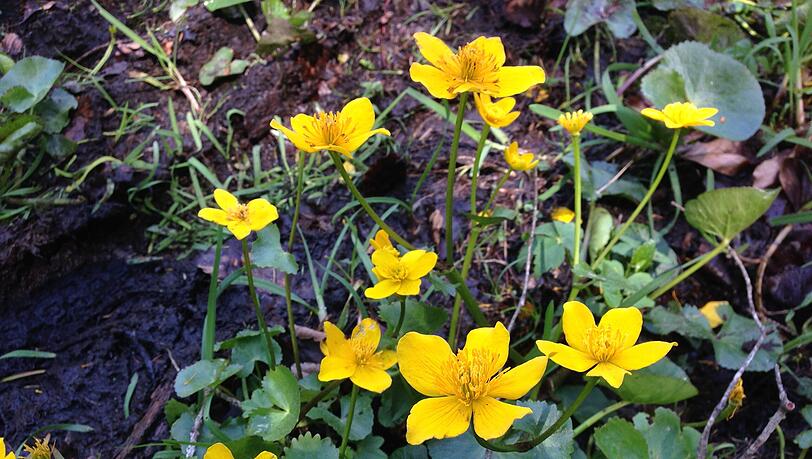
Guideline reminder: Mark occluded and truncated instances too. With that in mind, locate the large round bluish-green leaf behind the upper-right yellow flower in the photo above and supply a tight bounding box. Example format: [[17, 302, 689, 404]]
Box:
[[641, 41, 765, 140]]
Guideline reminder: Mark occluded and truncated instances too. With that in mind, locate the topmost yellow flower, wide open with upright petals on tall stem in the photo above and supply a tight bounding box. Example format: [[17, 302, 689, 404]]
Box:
[[409, 32, 545, 99]]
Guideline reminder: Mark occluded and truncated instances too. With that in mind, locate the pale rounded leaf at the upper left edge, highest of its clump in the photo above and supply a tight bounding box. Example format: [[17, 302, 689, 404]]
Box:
[[0, 56, 65, 113]]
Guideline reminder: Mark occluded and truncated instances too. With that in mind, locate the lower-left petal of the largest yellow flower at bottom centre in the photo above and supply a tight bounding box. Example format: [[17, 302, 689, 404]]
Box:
[[406, 397, 471, 445]]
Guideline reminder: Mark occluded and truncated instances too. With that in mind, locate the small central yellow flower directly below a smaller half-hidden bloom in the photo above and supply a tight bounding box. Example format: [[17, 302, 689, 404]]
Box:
[[364, 250, 437, 300]]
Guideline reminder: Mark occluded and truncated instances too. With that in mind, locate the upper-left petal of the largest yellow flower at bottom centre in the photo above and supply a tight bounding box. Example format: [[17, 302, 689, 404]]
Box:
[[397, 332, 456, 397]]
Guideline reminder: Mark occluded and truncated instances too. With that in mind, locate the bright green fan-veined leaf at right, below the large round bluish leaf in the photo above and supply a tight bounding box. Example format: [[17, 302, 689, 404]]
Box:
[[685, 187, 778, 240]]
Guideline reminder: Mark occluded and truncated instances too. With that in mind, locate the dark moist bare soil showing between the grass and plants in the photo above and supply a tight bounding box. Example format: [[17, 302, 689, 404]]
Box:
[[0, 0, 812, 458]]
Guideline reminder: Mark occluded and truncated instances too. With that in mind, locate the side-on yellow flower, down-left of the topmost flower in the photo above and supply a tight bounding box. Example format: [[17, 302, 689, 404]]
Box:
[[271, 97, 389, 156]]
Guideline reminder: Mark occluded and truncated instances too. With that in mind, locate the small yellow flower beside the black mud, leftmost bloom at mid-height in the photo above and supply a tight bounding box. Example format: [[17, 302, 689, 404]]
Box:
[[197, 188, 279, 240]]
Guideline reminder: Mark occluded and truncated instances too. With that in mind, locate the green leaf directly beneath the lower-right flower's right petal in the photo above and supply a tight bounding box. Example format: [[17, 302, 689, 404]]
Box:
[[613, 357, 699, 405]]
